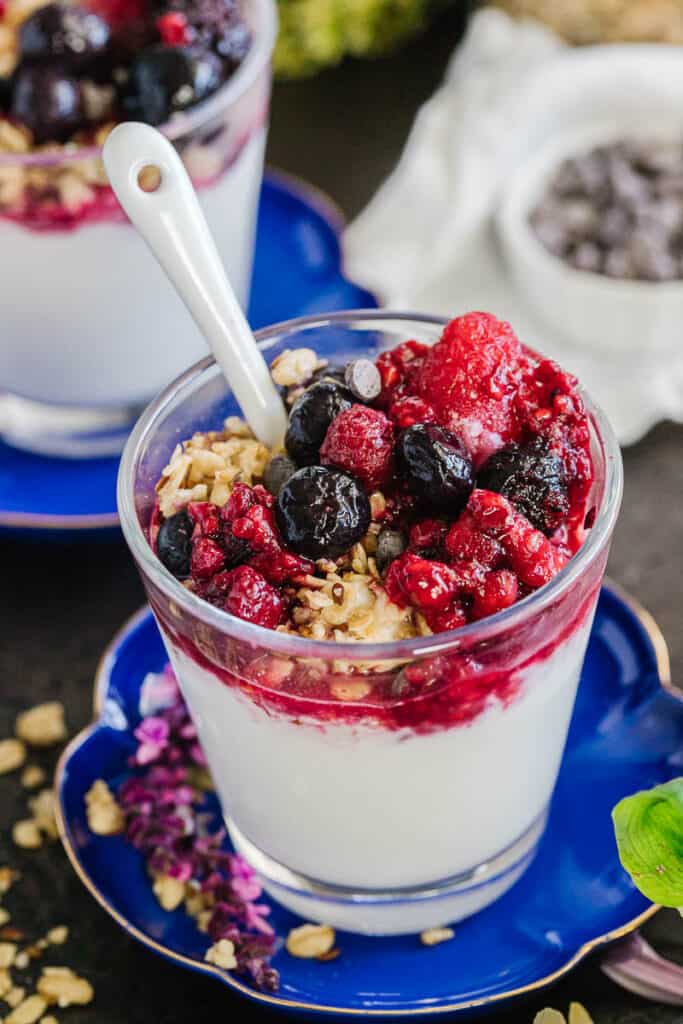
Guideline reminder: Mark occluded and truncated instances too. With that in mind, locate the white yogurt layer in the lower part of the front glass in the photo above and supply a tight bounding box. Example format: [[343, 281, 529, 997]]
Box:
[[158, 622, 590, 933]]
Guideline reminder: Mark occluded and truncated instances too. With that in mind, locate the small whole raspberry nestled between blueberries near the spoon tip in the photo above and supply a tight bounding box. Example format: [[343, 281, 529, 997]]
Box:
[[321, 406, 393, 490]]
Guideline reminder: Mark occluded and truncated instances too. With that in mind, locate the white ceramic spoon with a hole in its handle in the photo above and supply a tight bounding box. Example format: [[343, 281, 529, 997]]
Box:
[[102, 122, 287, 446]]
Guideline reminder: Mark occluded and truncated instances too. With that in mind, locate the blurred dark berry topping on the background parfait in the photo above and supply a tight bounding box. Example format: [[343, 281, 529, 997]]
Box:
[[0, 0, 251, 146]]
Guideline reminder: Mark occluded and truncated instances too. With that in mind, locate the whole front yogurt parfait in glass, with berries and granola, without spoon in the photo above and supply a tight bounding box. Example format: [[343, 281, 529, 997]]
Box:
[[119, 312, 622, 934]]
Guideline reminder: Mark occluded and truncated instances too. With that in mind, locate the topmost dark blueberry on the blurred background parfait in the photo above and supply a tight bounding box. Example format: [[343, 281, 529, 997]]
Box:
[[18, 3, 110, 65]]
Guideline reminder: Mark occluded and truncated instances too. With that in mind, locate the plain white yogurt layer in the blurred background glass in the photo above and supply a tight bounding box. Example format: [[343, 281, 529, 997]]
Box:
[[0, 128, 265, 408]]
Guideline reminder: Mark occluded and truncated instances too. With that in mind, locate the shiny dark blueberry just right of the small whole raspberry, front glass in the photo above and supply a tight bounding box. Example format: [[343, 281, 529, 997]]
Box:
[[396, 423, 474, 516]]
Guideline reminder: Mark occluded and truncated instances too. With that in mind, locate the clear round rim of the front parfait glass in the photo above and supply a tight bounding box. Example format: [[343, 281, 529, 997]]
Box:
[[117, 309, 624, 663]]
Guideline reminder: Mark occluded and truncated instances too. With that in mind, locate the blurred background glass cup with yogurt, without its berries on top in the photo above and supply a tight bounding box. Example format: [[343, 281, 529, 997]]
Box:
[[0, 0, 276, 456]]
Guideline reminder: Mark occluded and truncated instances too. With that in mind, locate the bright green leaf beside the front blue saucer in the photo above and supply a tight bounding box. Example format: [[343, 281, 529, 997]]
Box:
[[612, 778, 683, 907]]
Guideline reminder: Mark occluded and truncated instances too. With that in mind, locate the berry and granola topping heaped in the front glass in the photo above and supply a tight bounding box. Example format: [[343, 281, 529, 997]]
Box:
[[151, 313, 594, 655]]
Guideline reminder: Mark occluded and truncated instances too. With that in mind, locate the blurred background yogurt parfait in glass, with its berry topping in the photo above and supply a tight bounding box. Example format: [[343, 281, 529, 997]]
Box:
[[0, 0, 275, 455]]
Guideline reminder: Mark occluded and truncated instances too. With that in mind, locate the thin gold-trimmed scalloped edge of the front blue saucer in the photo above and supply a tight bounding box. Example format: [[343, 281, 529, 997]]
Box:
[[54, 580, 683, 1020]]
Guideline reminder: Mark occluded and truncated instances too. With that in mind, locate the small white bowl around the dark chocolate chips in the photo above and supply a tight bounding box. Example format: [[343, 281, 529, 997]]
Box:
[[497, 45, 683, 355]]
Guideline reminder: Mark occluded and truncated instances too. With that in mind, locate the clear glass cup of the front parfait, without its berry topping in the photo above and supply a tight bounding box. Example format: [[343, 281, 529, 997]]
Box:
[[119, 311, 622, 934]]
